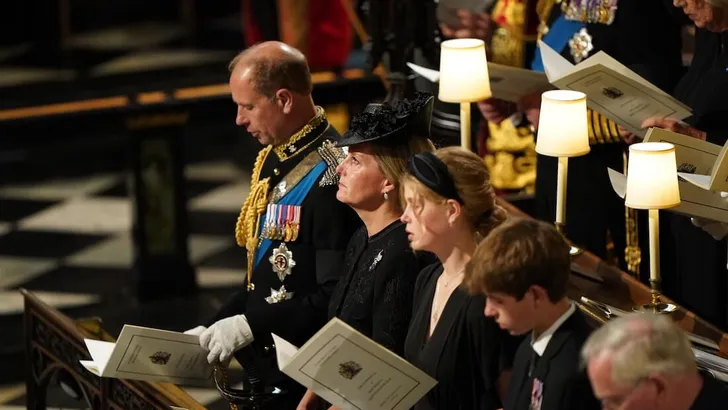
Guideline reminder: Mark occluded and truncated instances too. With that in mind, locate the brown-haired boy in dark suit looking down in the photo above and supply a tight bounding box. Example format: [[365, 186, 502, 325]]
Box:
[[464, 218, 601, 410]]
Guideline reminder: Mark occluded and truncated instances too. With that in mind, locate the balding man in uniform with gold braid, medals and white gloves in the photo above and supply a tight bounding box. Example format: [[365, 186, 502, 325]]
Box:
[[187, 42, 360, 407]]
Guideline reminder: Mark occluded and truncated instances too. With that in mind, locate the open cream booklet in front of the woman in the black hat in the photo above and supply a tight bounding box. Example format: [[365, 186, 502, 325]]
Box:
[[273, 318, 437, 410]]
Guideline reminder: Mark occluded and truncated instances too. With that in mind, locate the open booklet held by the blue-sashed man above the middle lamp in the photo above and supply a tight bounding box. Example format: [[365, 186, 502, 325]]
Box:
[[538, 40, 692, 137]]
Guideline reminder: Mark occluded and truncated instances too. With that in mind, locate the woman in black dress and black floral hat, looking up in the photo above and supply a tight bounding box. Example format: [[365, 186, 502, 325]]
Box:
[[298, 93, 434, 409]]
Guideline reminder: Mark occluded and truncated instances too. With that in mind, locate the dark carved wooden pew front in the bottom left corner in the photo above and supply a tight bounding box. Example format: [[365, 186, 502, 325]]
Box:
[[21, 290, 205, 410]]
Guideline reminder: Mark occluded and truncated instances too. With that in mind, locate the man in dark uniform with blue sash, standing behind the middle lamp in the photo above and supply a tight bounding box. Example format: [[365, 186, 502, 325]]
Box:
[[481, 0, 683, 271]]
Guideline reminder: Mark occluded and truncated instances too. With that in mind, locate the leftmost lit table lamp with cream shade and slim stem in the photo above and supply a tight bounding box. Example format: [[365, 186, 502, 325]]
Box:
[[438, 38, 492, 151]]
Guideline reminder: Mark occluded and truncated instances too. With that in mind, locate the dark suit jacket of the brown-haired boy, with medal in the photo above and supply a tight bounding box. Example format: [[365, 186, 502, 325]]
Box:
[[504, 308, 601, 410]]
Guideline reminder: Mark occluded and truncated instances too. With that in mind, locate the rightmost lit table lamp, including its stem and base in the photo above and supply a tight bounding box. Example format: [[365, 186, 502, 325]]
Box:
[[624, 142, 680, 313]]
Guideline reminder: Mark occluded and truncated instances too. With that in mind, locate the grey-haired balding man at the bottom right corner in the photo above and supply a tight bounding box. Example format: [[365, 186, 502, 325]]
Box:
[[582, 313, 728, 410]]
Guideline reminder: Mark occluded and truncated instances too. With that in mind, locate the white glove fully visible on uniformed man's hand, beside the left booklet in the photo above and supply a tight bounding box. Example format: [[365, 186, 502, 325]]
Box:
[[200, 315, 253, 364]]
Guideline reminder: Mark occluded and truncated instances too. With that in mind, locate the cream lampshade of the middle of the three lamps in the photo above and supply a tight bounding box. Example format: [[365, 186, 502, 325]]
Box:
[[536, 90, 590, 157]]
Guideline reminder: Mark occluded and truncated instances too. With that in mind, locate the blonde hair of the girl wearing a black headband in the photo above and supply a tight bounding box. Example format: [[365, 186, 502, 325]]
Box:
[[400, 147, 508, 241]]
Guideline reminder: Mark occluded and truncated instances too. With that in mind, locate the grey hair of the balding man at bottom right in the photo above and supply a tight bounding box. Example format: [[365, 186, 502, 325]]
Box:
[[581, 313, 697, 386]]
